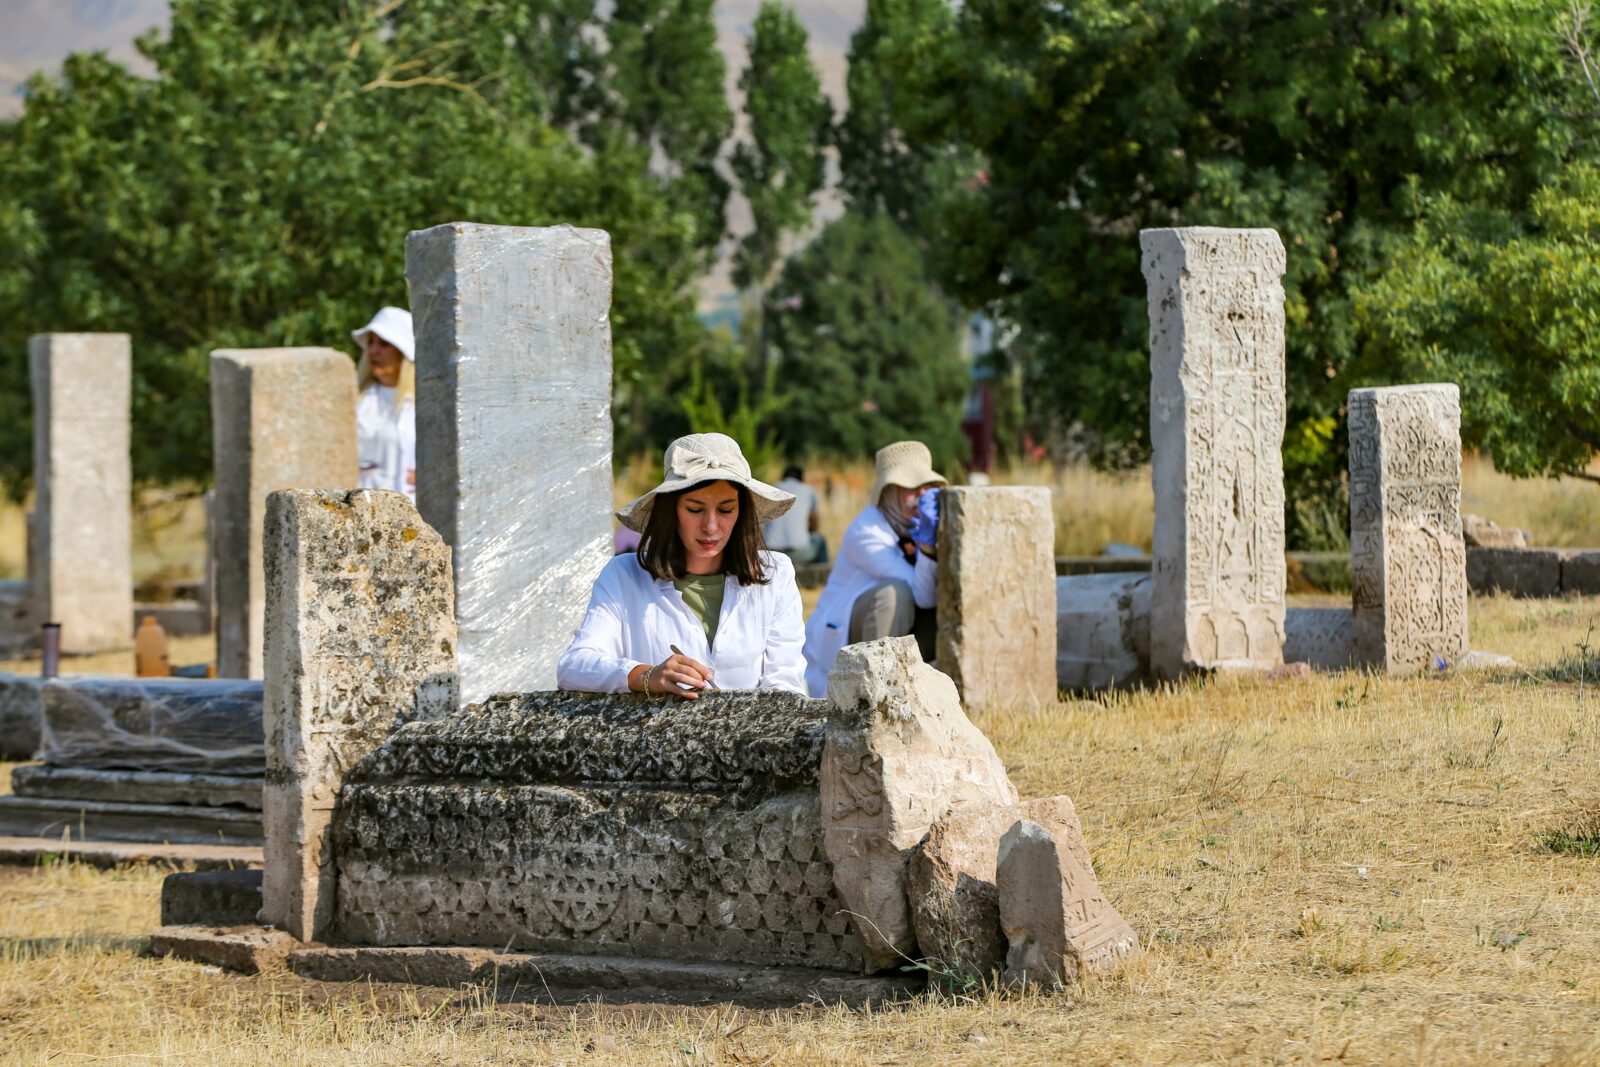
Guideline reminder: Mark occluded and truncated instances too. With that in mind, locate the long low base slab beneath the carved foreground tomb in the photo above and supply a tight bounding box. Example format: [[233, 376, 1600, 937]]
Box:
[[288, 945, 923, 1008]]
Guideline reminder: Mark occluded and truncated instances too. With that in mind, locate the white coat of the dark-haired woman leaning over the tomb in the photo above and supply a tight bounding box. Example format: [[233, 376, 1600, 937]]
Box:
[[555, 552, 805, 693]]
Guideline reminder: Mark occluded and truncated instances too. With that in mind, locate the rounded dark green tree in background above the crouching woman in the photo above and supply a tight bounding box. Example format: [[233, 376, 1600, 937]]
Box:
[[768, 214, 970, 467]]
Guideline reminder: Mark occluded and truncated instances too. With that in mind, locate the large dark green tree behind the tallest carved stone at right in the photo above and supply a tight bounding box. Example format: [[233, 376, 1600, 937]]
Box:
[[878, 0, 1574, 544]]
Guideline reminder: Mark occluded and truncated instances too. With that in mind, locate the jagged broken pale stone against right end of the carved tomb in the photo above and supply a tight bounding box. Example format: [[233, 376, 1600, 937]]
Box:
[[821, 637, 1016, 966]]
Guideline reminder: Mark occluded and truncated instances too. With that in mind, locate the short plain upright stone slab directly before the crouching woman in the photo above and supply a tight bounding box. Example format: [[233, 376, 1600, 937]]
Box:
[[938, 486, 1056, 707]]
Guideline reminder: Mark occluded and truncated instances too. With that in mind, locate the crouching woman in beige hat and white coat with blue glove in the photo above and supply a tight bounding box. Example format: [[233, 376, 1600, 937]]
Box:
[[805, 442, 949, 696]]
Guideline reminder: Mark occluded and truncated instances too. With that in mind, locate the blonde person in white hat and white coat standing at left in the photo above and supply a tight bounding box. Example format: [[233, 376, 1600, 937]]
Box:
[[350, 307, 416, 499]]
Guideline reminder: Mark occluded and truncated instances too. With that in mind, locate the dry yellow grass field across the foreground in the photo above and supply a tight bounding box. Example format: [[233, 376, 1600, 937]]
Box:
[[0, 598, 1600, 1067]]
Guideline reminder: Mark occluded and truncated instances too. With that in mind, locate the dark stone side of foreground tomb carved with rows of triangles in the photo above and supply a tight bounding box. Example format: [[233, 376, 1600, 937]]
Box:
[[336, 784, 864, 971]]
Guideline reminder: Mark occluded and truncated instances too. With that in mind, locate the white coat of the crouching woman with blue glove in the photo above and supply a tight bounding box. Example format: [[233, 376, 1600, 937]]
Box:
[[805, 504, 939, 696]]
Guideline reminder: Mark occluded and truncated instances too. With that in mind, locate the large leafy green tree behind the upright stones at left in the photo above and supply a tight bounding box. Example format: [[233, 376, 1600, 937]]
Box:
[[0, 0, 704, 493]]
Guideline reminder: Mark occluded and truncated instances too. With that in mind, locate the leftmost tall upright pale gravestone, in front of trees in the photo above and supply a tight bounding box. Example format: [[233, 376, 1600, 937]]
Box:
[[27, 333, 133, 653]]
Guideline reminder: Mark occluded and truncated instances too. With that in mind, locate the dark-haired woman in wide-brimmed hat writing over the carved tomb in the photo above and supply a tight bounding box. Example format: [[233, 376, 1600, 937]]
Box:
[[555, 434, 805, 697]]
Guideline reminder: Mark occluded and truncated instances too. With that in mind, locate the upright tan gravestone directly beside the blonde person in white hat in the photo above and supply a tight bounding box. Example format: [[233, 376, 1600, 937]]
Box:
[[211, 349, 358, 678]]
